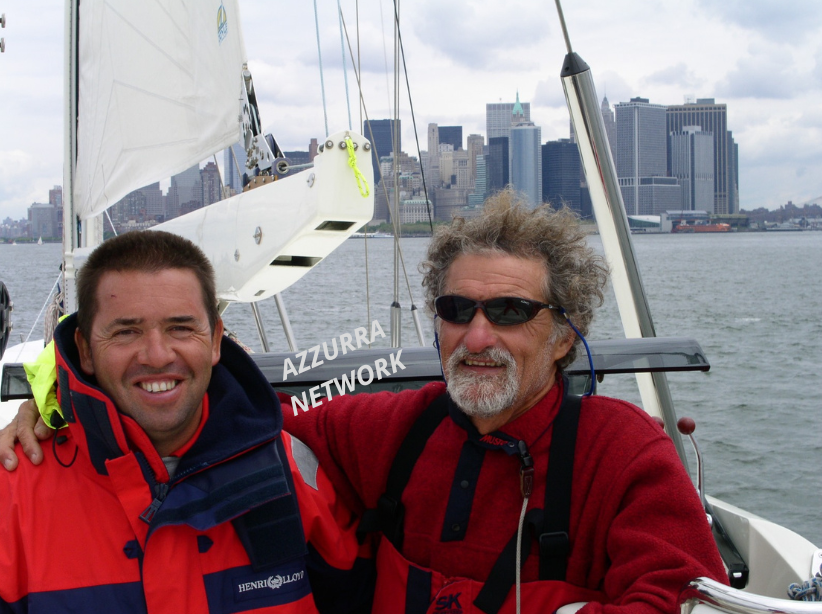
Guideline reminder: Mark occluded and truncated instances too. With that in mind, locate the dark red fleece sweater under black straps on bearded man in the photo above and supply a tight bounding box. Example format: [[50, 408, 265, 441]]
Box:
[[283, 383, 726, 614]]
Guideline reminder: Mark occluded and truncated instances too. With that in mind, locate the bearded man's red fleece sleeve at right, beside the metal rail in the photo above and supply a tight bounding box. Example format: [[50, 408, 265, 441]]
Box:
[[569, 400, 727, 614]]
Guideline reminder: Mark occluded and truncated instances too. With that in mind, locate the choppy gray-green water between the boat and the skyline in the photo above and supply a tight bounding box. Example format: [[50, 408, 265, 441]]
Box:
[[0, 232, 822, 545]]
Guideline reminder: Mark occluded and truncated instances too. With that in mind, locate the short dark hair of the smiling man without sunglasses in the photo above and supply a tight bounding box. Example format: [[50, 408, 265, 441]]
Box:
[[77, 230, 220, 338]]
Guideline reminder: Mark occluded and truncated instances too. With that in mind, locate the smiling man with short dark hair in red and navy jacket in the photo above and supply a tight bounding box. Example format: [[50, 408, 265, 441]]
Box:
[[0, 231, 370, 614]]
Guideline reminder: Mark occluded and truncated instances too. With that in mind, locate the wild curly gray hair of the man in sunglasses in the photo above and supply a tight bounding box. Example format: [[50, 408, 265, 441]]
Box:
[[420, 188, 608, 369]]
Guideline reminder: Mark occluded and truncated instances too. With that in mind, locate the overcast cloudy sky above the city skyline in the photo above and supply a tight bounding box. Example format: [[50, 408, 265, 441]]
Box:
[[0, 0, 822, 220]]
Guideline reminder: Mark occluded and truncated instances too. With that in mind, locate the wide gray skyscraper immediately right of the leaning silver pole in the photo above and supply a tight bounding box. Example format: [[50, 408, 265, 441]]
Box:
[[616, 98, 681, 215]]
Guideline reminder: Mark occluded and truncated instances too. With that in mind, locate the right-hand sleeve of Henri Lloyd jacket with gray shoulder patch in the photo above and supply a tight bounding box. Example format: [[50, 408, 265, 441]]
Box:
[[283, 433, 376, 614]]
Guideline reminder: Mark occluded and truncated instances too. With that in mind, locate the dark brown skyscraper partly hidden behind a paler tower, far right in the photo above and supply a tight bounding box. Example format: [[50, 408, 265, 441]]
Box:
[[666, 98, 739, 214]]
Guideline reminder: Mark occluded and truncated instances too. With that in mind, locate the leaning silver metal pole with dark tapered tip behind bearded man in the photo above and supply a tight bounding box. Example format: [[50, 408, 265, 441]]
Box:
[[556, 0, 688, 467]]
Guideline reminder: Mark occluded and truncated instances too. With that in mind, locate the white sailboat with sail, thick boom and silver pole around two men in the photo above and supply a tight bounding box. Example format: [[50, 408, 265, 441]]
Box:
[[3, 0, 822, 614]]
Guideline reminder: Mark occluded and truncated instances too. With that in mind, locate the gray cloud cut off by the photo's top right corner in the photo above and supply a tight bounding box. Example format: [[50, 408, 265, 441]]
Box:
[[698, 0, 822, 44]]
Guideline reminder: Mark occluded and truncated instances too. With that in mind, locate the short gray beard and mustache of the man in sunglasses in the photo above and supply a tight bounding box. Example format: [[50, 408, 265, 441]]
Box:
[[445, 346, 519, 418]]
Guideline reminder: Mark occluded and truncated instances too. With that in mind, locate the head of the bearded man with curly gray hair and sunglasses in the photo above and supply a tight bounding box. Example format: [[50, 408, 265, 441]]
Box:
[[421, 189, 608, 430]]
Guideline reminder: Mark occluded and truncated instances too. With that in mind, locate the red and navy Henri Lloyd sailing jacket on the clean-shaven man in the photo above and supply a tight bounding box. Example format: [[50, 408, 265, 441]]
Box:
[[0, 316, 373, 614]]
